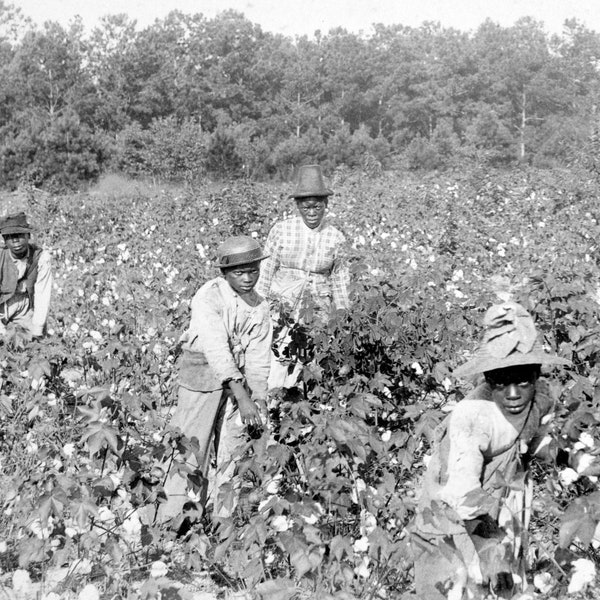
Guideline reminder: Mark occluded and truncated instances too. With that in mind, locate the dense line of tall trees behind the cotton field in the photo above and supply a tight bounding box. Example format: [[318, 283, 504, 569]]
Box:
[[0, 0, 600, 188]]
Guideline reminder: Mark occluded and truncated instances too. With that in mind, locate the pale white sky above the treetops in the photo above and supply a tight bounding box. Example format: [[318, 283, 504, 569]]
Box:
[[7, 0, 600, 37]]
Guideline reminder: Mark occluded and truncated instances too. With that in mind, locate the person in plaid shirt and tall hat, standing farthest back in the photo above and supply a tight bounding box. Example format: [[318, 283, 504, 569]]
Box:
[[257, 165, 350, 388]]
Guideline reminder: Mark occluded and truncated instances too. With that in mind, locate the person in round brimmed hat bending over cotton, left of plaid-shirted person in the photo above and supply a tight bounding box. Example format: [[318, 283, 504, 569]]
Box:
[[158, 236, 272, 521]]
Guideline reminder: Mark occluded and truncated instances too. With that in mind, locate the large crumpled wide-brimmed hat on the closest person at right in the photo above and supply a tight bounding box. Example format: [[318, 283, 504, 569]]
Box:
[[454, 301, 571, 378]]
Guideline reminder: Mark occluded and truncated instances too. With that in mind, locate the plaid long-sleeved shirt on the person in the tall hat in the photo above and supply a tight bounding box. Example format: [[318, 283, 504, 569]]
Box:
[[256, 217, 349, 308]]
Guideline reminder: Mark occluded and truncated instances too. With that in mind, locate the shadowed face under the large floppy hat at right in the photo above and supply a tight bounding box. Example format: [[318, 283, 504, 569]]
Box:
[[485, 365, 540, 416]]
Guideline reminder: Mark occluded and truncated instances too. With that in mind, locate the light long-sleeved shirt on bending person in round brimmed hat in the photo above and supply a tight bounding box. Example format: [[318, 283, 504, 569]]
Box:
[[179, 277, 272, 399]]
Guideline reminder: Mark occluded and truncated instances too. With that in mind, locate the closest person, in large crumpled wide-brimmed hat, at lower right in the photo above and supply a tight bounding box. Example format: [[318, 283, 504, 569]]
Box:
[[411, 301, 569, 599]]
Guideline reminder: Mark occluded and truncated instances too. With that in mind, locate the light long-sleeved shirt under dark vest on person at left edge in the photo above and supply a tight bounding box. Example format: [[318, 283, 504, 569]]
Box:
[[0, 250, 52, 336]]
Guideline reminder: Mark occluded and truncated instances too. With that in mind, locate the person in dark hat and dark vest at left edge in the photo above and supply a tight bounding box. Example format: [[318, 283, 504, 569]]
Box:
[[0, 212, 52, 338]]
